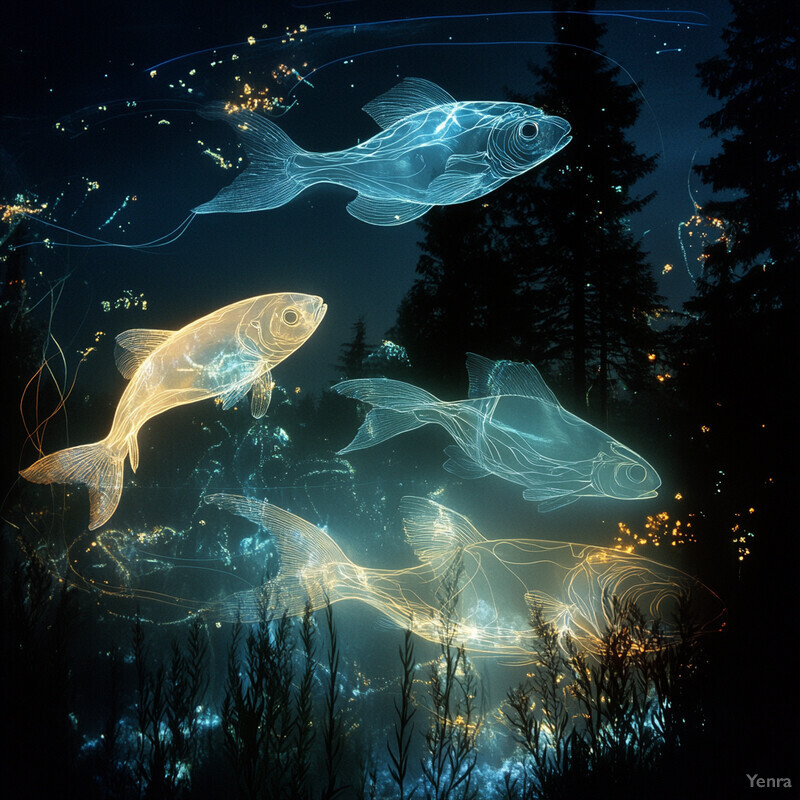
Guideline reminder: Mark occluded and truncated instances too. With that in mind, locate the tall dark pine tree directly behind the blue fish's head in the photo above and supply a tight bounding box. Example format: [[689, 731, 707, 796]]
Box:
[[493, 0, 659, 419]]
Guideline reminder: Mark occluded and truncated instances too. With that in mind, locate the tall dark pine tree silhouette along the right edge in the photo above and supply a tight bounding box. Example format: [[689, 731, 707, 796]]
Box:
[[677, 0, 800, 776]]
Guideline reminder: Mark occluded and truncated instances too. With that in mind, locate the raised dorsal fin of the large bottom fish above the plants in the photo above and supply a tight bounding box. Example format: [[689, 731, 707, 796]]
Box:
[[400, 497, 486, 575]]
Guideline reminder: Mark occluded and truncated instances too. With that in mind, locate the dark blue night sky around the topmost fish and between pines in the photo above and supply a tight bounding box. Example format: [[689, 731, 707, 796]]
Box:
[[0, 0, 729, 390]]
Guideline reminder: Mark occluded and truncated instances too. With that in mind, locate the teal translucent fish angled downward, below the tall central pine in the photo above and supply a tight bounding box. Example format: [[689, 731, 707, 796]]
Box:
[[333, 353, 661, 511]]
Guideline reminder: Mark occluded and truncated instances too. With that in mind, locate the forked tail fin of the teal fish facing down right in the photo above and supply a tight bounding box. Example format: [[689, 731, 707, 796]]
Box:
[[333, 378, 439, 453]]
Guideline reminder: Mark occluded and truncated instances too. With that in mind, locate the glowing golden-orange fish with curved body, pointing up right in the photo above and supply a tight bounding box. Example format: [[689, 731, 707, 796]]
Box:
[[20, 292, 327, 530]]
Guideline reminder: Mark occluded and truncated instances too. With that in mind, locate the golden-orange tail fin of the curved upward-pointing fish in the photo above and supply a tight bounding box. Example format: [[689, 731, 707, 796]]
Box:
[[20, 441, 127, 531]]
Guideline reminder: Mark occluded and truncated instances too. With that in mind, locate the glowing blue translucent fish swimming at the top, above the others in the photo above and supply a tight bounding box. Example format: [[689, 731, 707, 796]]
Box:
[[194, 78, 571, 225]]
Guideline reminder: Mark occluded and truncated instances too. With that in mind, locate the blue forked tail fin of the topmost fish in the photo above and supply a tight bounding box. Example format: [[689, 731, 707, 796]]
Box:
[[192, 105, 305, 214]]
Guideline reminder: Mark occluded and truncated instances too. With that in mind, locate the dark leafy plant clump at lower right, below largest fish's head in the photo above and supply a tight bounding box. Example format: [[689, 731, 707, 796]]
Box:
[[501, 598, 702, 800]]
